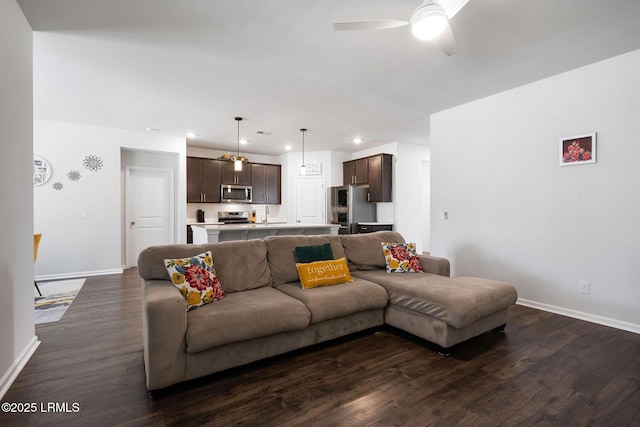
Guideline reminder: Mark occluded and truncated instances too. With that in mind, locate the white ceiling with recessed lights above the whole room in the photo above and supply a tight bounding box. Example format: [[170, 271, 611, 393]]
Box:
[[18, 0, 640, 155]]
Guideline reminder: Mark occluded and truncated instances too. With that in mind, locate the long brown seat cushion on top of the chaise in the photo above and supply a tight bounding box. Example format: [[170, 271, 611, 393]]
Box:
[[352, 270, 518, 328]]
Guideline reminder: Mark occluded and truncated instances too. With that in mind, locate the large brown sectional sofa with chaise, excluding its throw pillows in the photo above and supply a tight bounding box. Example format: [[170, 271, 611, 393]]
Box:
[[138, 231, 517, 390]]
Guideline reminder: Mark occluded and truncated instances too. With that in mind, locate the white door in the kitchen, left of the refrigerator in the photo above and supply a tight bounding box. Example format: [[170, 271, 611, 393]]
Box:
[[296, 176, 327, 224]]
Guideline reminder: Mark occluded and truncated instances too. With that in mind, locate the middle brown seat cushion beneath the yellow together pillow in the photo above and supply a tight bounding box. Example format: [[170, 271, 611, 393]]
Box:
[[277, 279, 389, 323]]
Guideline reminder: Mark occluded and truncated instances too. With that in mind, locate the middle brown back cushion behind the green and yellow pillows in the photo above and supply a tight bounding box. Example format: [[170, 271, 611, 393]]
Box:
[[264, 234, 344, 286]]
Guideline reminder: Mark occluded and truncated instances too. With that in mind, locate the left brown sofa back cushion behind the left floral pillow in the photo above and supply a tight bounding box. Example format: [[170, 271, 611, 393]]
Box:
[[138, 240, 272, 292]]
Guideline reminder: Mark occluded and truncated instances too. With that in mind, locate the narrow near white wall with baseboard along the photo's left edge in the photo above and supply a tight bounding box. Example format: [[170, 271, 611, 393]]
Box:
[[0, 0, 38, 399]]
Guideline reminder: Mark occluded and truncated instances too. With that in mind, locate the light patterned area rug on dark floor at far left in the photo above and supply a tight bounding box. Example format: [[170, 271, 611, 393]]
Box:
[[35, 279, 86, 325]]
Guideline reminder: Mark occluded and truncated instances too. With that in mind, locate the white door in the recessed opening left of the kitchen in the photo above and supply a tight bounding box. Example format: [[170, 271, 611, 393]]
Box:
[[125, 166, 175, 267]]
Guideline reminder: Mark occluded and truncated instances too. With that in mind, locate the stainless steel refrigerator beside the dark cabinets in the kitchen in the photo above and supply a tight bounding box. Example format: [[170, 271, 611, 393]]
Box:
[[328, 185, 376, 234]]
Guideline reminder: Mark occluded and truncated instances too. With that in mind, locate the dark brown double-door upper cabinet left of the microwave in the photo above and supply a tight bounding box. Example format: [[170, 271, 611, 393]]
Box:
[[187, 157, 222, 203]]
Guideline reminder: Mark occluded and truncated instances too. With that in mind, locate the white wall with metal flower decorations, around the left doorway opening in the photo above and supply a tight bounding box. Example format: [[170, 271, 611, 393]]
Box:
[[34, 120, 186, 279]]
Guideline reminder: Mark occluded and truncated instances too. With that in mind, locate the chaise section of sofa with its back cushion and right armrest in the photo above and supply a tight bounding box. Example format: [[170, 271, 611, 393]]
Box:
[[342, 232, 518, 354]]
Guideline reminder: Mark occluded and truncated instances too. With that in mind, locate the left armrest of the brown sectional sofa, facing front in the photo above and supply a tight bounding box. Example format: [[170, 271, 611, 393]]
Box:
[[142, 280, 187, 390]]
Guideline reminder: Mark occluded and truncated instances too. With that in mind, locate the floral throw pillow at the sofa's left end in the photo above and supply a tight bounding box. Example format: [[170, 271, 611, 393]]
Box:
[[164, 251, 224, 311]]
